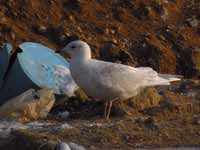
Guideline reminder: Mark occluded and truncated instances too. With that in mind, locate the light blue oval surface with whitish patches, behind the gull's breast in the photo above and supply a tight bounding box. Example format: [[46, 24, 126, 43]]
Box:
[[17, 42, 75, 95]]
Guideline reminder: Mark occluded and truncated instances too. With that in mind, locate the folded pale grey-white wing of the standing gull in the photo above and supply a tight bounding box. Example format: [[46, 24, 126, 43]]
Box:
[[87, 60, 169, 89]]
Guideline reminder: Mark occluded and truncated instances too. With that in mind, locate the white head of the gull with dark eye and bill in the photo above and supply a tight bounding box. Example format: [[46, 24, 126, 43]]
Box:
[[62, 40, 91, 59]]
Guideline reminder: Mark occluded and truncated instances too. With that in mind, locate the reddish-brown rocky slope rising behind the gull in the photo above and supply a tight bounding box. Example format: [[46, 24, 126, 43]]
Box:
[[0, 0, 200, 77]]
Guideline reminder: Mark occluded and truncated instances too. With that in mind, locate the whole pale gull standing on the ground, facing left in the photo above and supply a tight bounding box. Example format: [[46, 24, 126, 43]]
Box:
[[61, 40, 180, 120]]
